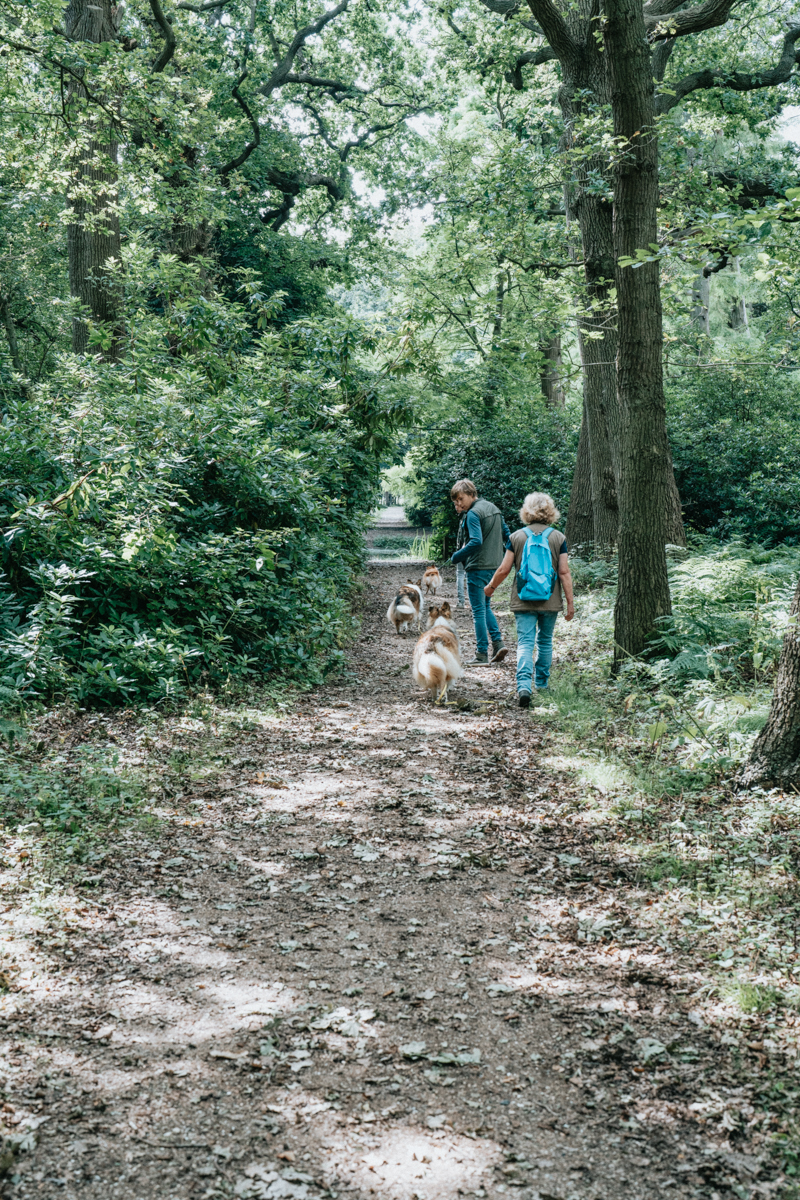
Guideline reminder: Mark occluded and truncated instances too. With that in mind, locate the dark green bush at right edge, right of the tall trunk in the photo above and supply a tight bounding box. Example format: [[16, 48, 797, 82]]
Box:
[[668, 368, 800, 546]]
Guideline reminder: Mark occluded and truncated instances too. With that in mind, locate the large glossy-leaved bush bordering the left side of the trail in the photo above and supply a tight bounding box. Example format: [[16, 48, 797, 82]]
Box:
[[0, 276, 407, 704]]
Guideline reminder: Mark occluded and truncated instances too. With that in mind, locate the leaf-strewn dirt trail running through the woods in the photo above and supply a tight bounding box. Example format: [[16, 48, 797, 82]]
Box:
[[4, 564, 770, 1200]]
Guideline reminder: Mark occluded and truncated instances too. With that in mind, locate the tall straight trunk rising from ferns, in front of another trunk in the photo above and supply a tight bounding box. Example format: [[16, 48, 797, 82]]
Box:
[[603, 0, 672, 667]]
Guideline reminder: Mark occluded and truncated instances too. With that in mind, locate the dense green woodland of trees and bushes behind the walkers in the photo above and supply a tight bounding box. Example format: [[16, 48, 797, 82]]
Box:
[[0, 0, 800, 758]]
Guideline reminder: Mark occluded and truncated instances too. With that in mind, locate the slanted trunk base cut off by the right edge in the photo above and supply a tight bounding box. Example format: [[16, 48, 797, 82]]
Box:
[[739, 583, 800, 791]]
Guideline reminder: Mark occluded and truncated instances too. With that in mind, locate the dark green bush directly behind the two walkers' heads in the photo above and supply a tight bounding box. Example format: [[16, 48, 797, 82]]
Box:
[[407, 401, 577, 547]]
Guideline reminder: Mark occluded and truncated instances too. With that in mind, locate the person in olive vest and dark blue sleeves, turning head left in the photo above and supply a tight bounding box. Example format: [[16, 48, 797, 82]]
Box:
[[450, 479, 511, 667]]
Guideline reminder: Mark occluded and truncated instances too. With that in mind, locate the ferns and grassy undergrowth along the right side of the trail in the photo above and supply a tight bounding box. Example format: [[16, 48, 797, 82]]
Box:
[[544, 544, 800, 1176]]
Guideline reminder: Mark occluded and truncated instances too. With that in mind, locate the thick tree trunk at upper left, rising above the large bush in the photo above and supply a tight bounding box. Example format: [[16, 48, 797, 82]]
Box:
[[65, 0, 122, 360]]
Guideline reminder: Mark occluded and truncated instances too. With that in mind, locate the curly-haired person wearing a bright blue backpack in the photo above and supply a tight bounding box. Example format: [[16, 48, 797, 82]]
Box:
[[485, 492, 575, 708]]
